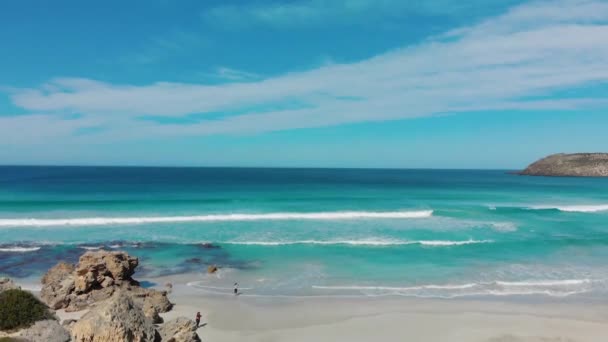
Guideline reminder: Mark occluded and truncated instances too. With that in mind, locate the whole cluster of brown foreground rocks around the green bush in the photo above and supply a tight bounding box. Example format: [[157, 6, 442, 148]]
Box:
[[0, 250, 200, 342]]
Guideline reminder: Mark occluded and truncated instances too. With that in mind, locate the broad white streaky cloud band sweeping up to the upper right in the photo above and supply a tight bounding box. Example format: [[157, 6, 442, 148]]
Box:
[[0, 0, 608, 143]]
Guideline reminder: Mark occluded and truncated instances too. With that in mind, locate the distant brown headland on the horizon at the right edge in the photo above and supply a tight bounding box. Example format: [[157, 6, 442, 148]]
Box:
[[520, 153, 608, 177]]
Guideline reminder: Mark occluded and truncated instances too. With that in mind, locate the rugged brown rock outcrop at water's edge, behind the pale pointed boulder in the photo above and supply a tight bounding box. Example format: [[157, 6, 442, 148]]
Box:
[[40, 251, 172, 320]]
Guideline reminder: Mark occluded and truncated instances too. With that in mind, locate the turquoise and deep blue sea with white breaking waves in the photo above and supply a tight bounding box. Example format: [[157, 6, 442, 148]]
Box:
[[0, 167, 608, 298]]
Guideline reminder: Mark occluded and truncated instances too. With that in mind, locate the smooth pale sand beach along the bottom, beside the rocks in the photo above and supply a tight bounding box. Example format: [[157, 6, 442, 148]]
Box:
[[65, 275, 608, 342]]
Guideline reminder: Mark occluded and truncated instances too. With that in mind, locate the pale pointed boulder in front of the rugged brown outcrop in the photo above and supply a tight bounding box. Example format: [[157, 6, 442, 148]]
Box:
[[71, 291, 159, 342]]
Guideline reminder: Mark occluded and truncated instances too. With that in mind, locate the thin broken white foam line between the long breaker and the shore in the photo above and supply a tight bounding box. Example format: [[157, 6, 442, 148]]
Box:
[[220, 239, 493, 247]]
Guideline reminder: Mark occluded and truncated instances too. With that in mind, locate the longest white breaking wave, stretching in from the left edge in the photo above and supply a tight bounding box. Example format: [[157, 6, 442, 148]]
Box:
[[0, 210, 433, 227]]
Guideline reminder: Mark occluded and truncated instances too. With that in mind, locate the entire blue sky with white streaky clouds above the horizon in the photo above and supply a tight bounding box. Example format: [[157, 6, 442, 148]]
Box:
[[0, 0, 608, 169]]
